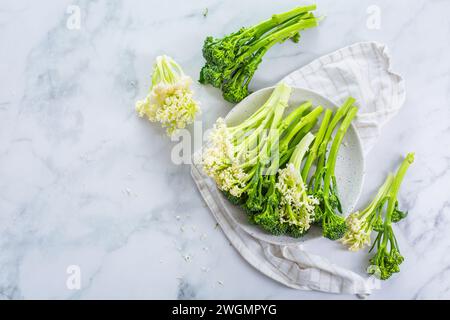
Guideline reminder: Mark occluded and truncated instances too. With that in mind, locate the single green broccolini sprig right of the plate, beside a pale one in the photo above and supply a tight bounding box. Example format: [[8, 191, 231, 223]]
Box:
[[367, 153, 414, 280]]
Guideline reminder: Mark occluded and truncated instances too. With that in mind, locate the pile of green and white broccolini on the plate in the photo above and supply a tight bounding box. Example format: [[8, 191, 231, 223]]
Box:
[[203, 84, 357, 239]]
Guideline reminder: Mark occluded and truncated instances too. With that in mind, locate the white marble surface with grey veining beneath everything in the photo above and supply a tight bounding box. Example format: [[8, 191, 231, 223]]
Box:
[[0, 0, 450, 299]]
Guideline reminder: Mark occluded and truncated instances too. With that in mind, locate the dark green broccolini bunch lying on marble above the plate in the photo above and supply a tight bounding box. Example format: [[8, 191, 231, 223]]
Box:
[[199, 5, 318, 102]]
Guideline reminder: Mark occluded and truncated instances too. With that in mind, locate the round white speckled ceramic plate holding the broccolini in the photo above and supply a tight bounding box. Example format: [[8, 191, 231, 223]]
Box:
[[223, 87, 364, 244]]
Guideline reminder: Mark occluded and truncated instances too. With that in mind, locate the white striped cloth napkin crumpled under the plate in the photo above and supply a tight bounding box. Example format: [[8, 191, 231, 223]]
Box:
[[191, 42, 405, 296]]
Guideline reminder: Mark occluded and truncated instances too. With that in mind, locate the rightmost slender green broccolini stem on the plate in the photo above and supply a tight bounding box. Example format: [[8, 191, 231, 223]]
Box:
[[323, 107, 358, 198]]
